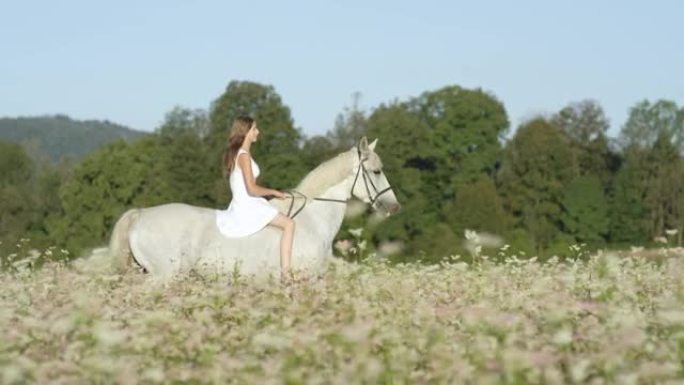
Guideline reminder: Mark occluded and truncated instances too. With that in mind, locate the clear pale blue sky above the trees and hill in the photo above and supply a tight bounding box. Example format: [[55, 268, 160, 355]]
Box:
[[0, 0, 684, 136]]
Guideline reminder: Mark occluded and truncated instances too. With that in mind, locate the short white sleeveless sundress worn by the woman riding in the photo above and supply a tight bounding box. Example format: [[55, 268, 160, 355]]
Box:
[[216, 149, 278, 238]]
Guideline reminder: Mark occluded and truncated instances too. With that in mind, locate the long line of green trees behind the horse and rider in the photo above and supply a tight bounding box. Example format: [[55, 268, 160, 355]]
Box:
[[0, 81, 684, 262]]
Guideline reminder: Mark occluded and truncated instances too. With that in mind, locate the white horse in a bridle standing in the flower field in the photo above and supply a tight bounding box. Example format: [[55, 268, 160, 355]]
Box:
[[109, 137, 400, 276]]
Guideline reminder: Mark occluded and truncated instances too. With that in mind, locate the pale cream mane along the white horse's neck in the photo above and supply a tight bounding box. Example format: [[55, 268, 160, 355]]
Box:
[[295, 151, 352, 198]]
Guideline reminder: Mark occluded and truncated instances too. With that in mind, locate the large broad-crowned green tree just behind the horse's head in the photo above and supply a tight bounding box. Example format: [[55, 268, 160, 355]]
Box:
[[367, 86, 508, 260]]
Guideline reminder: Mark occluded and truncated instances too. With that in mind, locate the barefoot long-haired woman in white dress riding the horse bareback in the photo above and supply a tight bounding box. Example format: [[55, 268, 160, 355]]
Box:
[[216, 116, 295, 278]]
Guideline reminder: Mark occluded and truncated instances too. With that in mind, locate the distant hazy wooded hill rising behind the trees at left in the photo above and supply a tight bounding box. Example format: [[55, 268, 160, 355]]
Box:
[[0, 115, 147, 160]]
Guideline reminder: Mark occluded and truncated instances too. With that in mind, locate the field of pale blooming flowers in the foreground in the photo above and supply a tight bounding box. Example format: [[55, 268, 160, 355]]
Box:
[[0, 250, 684, 384]]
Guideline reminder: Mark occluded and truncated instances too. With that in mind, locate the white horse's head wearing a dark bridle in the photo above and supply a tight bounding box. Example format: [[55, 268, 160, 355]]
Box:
[[350, 136, 401, 215]]
